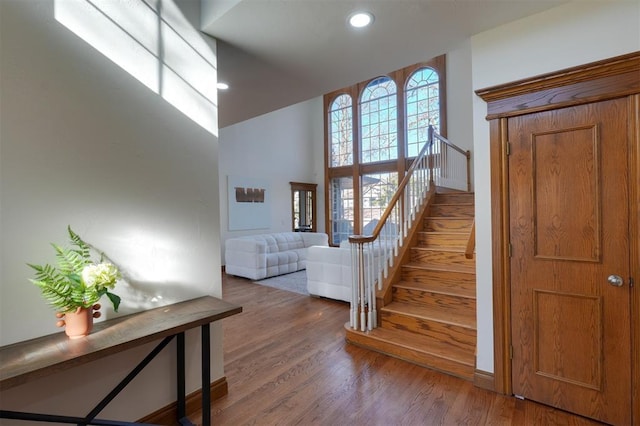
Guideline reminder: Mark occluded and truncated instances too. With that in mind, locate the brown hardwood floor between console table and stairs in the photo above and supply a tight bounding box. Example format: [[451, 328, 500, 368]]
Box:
[[192, 275, 599, 426]]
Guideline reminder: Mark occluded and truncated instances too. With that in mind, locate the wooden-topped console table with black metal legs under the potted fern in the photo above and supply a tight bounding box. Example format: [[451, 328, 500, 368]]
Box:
[[0, 296, 242, 425]]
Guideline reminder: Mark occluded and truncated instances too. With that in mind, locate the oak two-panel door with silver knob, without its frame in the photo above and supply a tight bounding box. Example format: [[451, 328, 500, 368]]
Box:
[[507, 98, 631, 425]]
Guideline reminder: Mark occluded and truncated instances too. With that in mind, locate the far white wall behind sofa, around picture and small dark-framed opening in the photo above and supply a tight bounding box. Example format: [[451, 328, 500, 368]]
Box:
[[218, 97, 325, 263]]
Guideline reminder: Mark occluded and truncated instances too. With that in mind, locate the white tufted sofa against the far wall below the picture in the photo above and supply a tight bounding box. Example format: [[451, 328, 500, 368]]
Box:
[[225, 232, 329, 280]]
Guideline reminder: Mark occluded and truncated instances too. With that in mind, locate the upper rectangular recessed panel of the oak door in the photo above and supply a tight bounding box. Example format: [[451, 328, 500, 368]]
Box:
[[531, 125, 602, 262]]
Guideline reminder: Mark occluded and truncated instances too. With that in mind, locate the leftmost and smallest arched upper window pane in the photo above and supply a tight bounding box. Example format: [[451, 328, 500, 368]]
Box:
[[329, 94, 353, 167]]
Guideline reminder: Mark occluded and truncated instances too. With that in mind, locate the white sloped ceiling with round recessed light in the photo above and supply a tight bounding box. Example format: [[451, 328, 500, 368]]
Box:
[[201, 0, 567, 128]]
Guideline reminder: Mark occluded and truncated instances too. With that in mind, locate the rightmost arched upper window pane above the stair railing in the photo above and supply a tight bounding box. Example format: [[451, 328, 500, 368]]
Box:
[[405, 67, 440, 157]]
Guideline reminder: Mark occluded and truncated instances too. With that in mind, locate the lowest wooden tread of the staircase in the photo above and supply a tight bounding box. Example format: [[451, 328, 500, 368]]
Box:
[[346, 324, 475, 367]]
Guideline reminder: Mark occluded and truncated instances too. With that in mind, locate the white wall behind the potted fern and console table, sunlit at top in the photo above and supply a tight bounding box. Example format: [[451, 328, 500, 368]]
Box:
[[0, 0, 223, 424]]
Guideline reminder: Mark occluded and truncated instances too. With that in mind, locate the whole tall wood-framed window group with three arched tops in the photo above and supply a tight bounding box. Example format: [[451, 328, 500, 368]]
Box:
[[324, 56, 446, 245]]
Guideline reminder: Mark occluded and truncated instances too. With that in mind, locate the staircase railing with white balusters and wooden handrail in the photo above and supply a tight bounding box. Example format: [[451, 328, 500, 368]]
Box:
[[349, 126, 471, 331]]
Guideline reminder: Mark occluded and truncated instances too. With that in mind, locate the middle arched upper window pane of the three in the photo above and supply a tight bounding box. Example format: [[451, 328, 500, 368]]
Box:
[[360, 76, 398, 163]]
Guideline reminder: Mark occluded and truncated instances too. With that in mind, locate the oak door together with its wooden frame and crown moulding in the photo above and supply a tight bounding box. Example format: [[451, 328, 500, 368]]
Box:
[[476, 52, 640, 424]]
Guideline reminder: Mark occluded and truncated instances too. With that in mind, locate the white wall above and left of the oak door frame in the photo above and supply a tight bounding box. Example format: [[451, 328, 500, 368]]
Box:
[[471, 1, 640, 372]]
